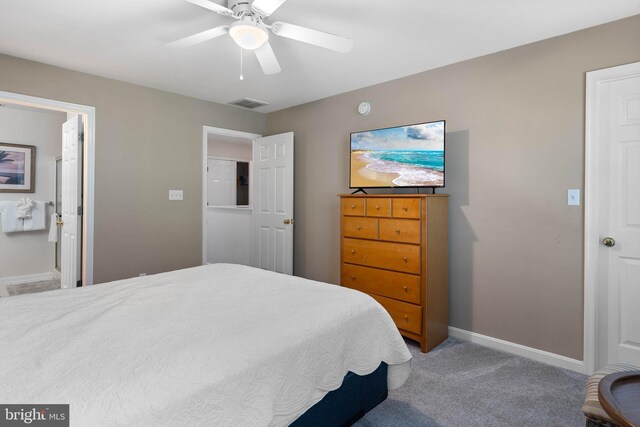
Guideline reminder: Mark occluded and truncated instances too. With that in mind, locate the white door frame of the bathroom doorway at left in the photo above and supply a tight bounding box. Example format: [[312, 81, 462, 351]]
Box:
[[0, 91, 96, 286]]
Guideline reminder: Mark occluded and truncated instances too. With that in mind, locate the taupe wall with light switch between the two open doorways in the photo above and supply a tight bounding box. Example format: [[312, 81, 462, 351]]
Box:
[[0, 55, 266, 283]]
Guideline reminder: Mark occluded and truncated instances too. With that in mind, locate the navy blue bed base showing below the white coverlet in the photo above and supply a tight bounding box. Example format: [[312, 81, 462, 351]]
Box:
[[291, 362, 388, 427]]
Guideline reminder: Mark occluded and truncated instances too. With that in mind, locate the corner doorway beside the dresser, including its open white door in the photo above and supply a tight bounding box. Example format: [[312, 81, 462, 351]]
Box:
[[202, 126, 294, 274]]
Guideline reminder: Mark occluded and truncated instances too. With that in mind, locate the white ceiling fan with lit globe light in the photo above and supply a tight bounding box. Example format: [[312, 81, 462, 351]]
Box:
[[167, 0, 353, 74]]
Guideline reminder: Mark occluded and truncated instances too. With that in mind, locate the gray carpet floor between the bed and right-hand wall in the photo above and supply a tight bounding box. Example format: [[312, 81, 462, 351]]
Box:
[[355, 338, 587, 427]]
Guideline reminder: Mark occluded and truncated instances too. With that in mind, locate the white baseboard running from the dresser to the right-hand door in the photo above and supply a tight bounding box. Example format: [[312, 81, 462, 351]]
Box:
[[449, 326, 585, 373]]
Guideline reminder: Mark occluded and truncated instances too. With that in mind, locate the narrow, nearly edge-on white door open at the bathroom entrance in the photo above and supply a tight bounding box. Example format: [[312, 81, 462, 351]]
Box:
[[60, 116, 82, 288]]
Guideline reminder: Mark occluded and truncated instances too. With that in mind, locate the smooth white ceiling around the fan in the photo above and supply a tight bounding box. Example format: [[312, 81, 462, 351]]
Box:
[[0, 0, 640, 112]]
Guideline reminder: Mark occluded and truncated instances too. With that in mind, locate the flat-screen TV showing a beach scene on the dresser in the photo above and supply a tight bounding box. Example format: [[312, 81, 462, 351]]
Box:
[[349, 120, 445, 188]]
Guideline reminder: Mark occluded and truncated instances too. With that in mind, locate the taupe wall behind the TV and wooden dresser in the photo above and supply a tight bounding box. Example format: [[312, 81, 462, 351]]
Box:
[[267, 15, 640, 360]]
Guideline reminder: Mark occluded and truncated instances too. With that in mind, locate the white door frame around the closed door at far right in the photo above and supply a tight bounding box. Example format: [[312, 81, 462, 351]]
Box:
[[583, 62, 640, 374]]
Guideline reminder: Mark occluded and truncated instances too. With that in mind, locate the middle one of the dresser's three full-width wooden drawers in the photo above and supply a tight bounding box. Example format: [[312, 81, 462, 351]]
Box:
[[340, 264, 420, 304]]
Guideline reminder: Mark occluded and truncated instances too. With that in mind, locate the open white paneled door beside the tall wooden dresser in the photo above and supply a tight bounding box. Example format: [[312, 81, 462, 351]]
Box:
[[252, 132, 293, 274]]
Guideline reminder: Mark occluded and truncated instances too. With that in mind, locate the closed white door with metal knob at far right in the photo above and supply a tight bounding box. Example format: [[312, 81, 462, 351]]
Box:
[[596, 63, 640, 366]]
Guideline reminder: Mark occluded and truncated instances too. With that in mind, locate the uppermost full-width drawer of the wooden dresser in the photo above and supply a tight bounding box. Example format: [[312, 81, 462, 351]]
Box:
[[342, 238, 420, 274]]
